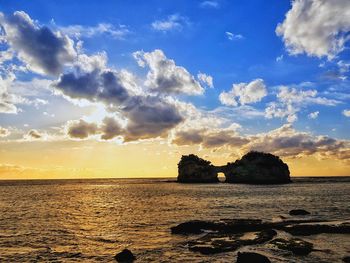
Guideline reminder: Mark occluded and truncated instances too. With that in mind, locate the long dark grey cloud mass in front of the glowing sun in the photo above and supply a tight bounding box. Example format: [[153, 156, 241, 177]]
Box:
[[58, 52, 184, 141]]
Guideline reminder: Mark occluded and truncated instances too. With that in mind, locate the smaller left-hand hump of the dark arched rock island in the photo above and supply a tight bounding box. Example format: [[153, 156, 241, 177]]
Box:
[[177, 154, 219, 183]]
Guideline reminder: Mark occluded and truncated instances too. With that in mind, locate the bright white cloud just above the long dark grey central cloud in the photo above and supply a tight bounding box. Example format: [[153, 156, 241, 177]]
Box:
[[133, 49, 204, 95]]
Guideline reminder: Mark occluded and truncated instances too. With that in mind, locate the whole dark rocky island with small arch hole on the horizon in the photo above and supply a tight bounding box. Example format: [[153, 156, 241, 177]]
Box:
[[177, 151, 291, 184]]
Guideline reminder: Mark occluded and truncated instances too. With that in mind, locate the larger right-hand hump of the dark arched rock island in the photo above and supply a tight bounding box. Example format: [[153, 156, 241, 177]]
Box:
[[224, 152, 291, 184]]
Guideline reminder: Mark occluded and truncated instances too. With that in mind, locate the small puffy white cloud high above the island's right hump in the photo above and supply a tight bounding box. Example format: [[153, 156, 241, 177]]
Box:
[[219, 79, 267, 106]]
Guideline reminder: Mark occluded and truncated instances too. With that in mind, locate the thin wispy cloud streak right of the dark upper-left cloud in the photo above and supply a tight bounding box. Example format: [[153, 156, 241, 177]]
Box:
[[59, 23, 130, 39]]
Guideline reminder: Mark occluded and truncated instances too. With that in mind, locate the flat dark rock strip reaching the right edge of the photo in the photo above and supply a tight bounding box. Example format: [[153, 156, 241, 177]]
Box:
[[283, 222, 350, 236]]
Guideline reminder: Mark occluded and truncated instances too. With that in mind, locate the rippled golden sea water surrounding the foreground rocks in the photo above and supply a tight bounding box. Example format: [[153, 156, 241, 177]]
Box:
[[0, 177, 350, 262]]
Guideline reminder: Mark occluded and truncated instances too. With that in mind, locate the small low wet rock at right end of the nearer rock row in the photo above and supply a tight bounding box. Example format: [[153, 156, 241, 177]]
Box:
[[271, 238, 313, 255]]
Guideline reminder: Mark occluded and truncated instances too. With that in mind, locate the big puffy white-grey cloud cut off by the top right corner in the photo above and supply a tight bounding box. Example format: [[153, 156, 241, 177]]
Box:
[[276, 0, 350, 59]]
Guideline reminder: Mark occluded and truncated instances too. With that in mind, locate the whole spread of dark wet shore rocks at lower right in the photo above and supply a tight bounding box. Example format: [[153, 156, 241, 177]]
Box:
[[171, 211, 350, 263]]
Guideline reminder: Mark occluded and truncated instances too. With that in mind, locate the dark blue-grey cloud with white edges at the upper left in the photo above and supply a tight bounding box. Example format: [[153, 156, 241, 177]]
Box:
[[0, 11, 76, 75]]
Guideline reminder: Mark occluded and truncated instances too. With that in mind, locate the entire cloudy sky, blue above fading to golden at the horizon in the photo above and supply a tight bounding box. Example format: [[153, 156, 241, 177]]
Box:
[[0, 0, 350, 179]]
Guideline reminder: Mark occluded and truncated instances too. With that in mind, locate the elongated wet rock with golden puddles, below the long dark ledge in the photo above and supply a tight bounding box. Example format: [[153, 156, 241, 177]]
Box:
[[188, 229, 277, 255]]
